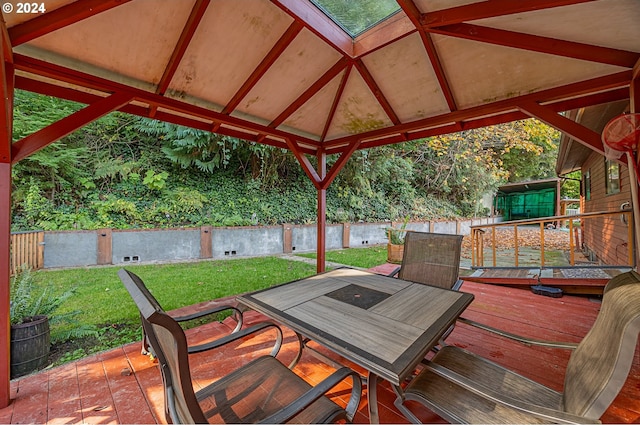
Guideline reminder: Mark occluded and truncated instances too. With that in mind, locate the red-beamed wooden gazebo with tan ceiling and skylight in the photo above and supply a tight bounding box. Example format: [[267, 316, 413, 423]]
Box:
[[0, 0, 640, 407]]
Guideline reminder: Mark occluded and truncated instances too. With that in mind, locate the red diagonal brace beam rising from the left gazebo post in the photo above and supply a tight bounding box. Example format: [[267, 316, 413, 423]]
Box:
[[11, 93, 133, 163]]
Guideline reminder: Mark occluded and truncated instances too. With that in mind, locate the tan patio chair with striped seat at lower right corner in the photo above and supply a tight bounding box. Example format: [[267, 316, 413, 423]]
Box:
[[395, 271, 640, 423]]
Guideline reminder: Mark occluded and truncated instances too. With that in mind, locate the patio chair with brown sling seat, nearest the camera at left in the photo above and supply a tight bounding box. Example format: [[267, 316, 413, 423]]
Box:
[[119, 269, 362, 423]]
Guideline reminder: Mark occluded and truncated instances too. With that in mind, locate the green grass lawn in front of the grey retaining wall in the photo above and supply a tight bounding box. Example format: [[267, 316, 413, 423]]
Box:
[[33, 246, 387, 365]]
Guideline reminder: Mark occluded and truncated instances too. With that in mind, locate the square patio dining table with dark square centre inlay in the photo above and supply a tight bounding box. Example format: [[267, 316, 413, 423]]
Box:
[[238, 268, 473, 423]]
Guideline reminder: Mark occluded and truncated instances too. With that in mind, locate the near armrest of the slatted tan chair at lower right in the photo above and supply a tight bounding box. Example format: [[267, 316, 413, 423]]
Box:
[[424, 362, 601, 424]]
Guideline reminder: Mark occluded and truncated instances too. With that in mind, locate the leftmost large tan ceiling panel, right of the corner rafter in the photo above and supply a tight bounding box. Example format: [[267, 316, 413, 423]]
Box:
[[16, 0, 193, 87]]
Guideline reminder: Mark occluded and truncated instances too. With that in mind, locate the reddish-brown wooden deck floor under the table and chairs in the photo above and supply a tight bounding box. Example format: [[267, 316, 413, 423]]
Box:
[[0, 267, 640, 424]]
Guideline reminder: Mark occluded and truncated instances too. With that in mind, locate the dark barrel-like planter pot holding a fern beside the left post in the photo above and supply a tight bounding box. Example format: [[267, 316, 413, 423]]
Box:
[[11, 316, 50, 379]]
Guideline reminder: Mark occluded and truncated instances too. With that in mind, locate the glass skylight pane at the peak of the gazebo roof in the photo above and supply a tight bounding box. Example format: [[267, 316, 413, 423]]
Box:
[[310, 0, 400, 38]]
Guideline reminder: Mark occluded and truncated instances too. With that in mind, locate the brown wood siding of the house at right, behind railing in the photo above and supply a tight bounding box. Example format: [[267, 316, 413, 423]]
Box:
[[581, 153, 631, 265]]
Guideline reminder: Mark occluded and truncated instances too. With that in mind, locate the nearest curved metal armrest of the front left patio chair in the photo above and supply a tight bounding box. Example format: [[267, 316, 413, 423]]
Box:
[[260, 367, 362, 424]]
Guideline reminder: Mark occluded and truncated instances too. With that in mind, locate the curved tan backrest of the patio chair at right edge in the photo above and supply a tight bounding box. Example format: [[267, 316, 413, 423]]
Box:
[[564, 271, 640, 419]]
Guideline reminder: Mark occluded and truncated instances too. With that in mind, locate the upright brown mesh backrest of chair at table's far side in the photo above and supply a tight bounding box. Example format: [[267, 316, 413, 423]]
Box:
[[398, 232, 463, 289]]
